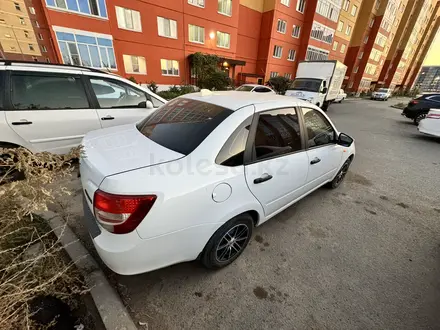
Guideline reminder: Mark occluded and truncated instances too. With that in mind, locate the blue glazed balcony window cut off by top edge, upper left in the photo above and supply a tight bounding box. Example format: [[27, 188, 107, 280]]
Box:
[[46, 0, 107, 18]]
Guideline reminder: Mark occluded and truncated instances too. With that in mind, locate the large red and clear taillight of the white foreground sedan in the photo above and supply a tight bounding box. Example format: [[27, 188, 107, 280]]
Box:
[[93, 190, 157, 234]]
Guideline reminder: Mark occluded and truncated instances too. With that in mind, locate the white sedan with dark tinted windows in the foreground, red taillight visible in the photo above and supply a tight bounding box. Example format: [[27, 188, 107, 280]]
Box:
[[81, 90, 355, 275]]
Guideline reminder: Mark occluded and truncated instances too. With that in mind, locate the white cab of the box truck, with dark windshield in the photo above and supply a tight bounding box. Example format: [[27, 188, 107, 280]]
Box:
[[286, 78, 327, 107]]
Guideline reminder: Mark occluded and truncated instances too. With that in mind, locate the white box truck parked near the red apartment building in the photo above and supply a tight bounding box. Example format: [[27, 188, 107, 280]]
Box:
[[286, 61, 347, 111]]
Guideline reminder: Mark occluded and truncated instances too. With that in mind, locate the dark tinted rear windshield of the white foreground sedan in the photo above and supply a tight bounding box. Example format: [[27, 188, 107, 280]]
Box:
[[137, 98, 233, 155]]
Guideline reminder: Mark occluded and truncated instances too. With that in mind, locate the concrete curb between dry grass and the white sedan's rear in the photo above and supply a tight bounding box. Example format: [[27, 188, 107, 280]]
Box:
[[40, 211, 138, 330]]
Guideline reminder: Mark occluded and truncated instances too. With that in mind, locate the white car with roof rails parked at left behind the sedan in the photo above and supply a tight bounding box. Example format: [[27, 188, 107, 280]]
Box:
[[0, 60, 166, 154]]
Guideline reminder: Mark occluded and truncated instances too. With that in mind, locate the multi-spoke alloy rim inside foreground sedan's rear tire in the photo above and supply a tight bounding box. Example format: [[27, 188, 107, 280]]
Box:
[[215, 224, 249, 262]]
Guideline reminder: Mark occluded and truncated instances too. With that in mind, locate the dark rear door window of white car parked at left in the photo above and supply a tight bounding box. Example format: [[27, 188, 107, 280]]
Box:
[[11, 72, 89, 110]]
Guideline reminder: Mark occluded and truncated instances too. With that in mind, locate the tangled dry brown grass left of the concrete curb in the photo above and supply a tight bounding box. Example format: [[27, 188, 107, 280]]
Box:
[[0, 148, 86, 330]]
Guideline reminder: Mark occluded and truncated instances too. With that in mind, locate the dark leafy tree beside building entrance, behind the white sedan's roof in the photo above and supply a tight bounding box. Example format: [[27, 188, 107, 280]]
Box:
[[192, 52, 231, 90]]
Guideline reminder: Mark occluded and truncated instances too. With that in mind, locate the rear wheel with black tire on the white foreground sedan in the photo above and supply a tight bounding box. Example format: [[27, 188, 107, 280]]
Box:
[[200, 213, 254, 269]]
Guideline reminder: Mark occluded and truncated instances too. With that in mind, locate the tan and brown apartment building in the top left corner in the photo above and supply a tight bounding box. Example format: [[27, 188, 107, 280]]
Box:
[[0, 0, 56, 62]]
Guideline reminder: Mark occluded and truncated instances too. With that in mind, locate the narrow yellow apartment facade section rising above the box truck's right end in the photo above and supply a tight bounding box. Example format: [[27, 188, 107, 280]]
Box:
[[329, 0, 362, 63]]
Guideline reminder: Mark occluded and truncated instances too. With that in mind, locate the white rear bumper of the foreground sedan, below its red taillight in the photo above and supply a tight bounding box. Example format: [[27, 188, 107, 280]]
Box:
[[84, 197, 222, 275]]
